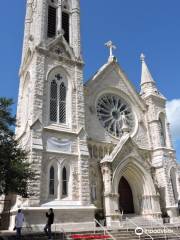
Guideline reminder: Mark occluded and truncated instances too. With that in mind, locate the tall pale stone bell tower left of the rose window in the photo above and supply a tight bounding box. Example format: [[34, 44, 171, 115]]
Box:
[[12, 0, 94, 230]]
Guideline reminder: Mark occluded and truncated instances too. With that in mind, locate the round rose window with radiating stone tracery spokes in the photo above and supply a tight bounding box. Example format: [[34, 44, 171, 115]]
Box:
[[96, 94, 135, 138]]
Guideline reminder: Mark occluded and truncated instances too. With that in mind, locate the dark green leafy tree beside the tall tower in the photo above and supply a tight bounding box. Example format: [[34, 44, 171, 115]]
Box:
[[0, 98, 34, 197]]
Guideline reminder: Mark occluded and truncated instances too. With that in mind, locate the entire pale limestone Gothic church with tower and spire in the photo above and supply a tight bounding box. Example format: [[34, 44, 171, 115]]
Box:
[[11, 0, 180, 227]]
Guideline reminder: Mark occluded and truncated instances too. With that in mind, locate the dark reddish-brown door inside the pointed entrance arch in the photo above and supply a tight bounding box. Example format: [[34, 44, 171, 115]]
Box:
[[118, 177, 134, 214]]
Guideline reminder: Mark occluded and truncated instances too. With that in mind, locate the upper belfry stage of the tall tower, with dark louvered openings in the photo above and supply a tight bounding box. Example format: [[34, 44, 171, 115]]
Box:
[[22, 0, 81, 60]]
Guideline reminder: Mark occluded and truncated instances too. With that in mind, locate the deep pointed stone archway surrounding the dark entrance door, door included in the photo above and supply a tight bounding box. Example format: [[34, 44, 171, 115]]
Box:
[[112, 157, 160, 215]]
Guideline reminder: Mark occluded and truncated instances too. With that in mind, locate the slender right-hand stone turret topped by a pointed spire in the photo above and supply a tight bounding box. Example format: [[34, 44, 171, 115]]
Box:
[[140, 54, 179, 217]]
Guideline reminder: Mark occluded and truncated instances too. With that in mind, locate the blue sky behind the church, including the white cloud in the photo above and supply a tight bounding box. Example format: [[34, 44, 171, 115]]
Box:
[[0, 0, 180, 161]]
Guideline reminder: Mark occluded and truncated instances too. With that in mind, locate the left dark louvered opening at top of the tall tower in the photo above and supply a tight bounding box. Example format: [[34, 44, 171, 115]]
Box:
[[47, 6, 56, 38]]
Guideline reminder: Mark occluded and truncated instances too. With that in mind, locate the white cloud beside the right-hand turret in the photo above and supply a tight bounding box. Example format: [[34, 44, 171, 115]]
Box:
[[166, 99, 180, 141]]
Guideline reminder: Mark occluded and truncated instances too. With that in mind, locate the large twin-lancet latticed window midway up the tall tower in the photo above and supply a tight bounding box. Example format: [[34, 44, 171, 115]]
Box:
[[49, 76, 67, 124]]
